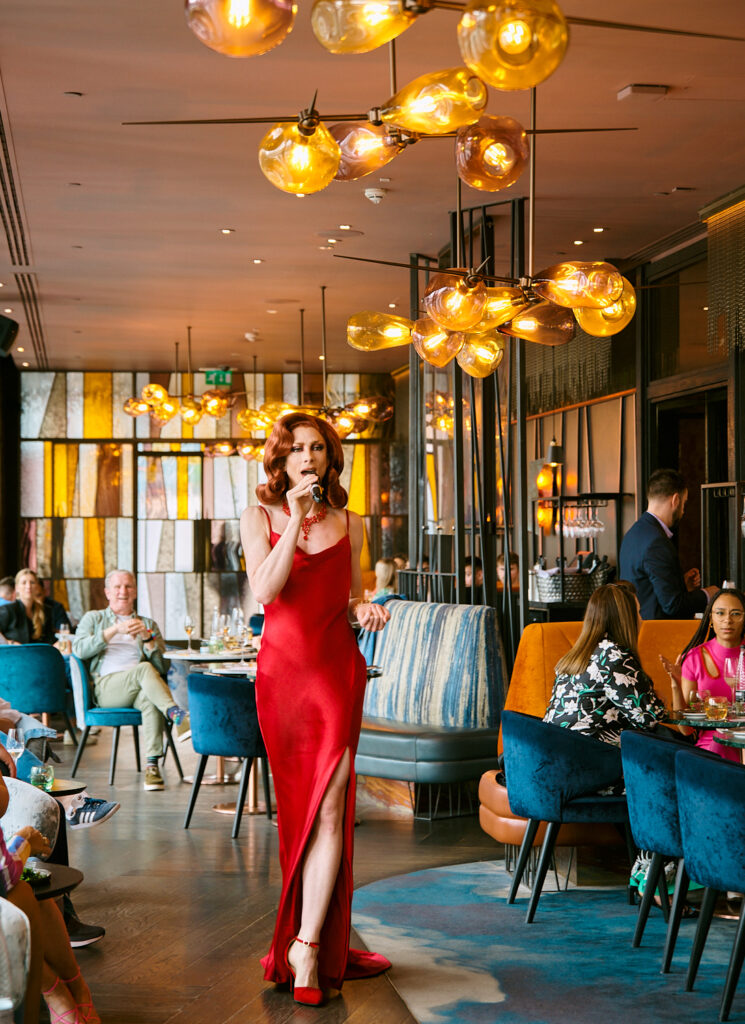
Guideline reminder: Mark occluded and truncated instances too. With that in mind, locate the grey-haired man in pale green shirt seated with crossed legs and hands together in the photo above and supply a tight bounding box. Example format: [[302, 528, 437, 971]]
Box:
[[73, 569, 186, 790]]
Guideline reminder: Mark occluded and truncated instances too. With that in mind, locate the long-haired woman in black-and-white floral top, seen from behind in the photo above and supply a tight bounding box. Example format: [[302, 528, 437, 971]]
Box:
[[543, 583, 684, 745]]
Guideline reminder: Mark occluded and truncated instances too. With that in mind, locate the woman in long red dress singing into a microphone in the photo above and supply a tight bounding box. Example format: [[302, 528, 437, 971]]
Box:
[[240, 413, 390, 1005]]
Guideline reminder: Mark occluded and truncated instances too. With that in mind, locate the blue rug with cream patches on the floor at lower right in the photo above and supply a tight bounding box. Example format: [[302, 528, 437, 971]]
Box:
[[352, 861, 745, 1024]]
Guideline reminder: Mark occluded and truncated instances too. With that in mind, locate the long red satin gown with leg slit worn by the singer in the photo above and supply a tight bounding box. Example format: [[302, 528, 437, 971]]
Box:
[[256, 509, 390, 988]]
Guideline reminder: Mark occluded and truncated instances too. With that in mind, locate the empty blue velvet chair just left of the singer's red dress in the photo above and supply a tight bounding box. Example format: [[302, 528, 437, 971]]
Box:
[[183, 672, 271, 839]]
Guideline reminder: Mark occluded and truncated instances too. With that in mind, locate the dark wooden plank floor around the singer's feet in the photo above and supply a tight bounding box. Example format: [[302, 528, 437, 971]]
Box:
[[55, 730, 501, 1024]]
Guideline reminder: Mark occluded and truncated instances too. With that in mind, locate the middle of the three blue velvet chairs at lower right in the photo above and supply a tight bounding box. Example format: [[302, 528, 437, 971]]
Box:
[[621, 729, 689, 962]]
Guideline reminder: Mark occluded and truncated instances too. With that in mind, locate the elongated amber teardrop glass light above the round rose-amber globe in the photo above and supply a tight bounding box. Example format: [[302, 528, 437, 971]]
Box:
[[380, 68, 488, 135]]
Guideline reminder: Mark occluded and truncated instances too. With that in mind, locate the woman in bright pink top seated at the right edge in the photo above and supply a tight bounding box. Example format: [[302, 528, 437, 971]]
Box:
[[681, 590, 745, 763]]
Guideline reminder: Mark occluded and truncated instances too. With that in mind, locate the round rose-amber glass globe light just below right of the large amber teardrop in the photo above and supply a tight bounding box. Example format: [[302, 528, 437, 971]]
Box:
[[455, 115, 530, 191]]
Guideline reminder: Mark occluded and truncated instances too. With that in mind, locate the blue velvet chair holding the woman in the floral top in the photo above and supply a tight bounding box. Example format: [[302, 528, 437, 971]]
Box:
[[501, 711, 631, 924]]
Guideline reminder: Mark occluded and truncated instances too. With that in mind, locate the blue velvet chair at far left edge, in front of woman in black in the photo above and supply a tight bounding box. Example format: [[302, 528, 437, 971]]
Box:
[[0, 643, 78, 742]]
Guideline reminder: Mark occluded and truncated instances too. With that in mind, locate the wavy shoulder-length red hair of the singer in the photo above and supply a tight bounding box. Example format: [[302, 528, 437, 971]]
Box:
[[256, 413, 348, 509]]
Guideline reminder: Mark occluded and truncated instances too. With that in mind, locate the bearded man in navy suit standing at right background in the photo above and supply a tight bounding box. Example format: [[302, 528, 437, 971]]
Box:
[[619, 469, 716, 618]]
